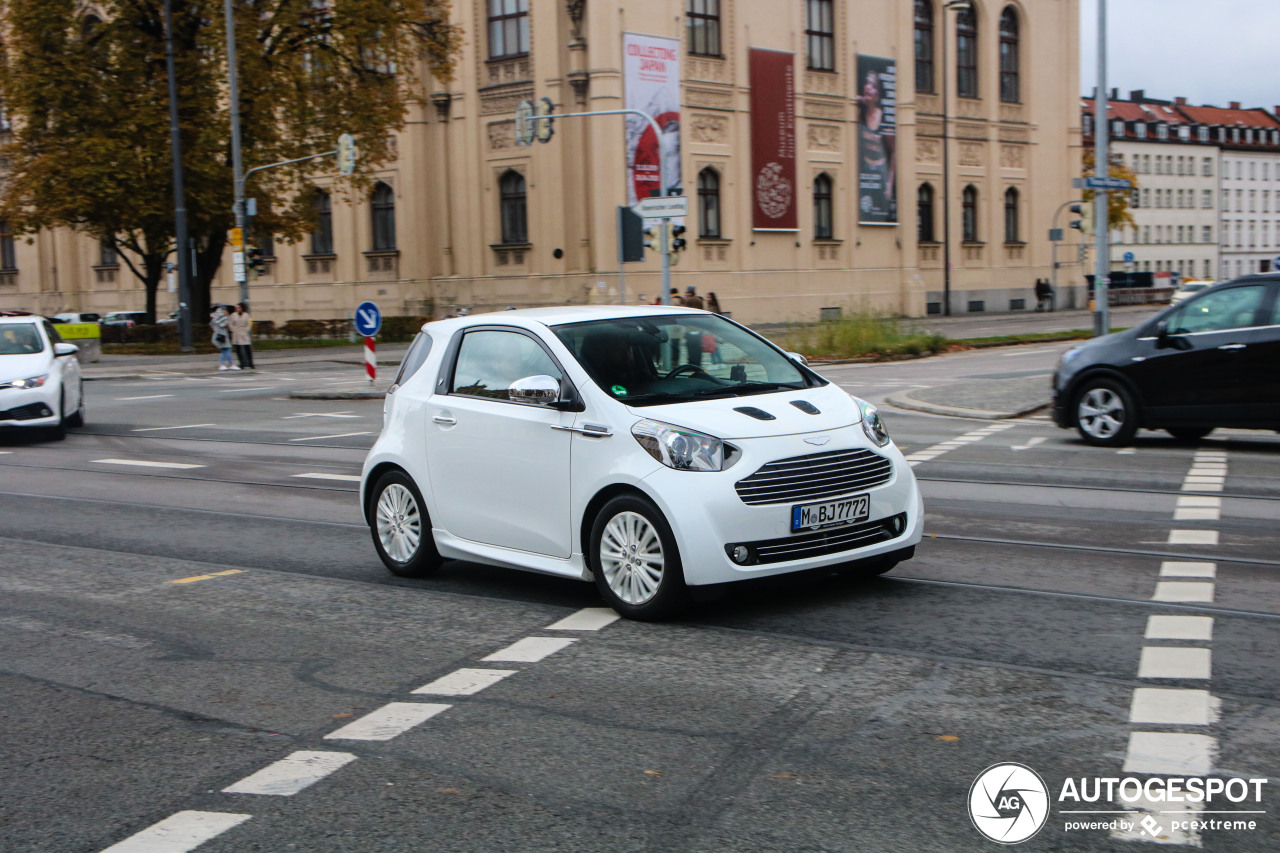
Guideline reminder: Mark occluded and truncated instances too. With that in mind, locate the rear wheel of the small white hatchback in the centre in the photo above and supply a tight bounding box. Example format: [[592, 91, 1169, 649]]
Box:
[[369, 471, 443, 578]]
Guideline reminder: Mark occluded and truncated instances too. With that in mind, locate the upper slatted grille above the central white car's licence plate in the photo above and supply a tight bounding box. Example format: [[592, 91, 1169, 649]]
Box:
[[733, 450, 893, 506]]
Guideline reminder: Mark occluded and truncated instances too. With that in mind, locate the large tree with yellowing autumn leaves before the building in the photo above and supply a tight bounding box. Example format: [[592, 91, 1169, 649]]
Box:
[[0, 0, 461, 319]]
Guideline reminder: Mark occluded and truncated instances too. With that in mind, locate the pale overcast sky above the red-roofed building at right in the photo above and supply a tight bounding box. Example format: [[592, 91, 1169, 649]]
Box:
[[1080, 0, 1280, 110]]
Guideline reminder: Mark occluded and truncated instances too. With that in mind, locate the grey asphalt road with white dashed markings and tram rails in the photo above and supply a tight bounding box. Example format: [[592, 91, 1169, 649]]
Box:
[[0, 345, 1280, 853]]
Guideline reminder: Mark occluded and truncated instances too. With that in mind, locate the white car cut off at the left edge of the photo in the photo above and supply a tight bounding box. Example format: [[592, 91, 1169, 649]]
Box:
[[0, 315, 84, 438]]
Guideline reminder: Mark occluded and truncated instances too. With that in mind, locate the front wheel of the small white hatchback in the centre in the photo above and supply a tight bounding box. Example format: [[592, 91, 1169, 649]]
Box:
[[589, 494, 689, 621]]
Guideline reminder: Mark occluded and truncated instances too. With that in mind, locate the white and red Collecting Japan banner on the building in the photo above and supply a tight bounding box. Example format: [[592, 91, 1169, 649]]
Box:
[[622, 32, 684, 206]]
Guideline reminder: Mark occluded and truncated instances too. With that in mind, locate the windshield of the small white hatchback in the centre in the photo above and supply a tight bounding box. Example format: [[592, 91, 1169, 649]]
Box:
[[554, 314, 822, 406]]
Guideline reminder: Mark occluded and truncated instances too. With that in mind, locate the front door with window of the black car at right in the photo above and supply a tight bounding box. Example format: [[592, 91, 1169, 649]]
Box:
[[1130, 282, 1270, 425]]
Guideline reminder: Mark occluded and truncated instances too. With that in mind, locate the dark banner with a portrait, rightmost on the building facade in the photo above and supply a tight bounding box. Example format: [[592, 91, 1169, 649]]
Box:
[[858, 54, 897, 225]]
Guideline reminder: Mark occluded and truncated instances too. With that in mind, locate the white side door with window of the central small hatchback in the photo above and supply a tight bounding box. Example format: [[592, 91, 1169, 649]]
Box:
[[426, 327, 573, 558]]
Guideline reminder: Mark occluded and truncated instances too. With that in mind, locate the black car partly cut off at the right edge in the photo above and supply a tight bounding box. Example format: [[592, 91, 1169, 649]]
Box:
[[1053, 274, 1280, 447]]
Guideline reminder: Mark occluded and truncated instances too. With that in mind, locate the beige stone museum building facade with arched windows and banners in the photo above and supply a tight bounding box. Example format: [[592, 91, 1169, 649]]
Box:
[[0, 0, 1083, 321]]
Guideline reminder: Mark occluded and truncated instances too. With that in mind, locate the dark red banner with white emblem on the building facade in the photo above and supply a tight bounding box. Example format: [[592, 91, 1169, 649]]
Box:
[[749, 47, 799, 231]]
